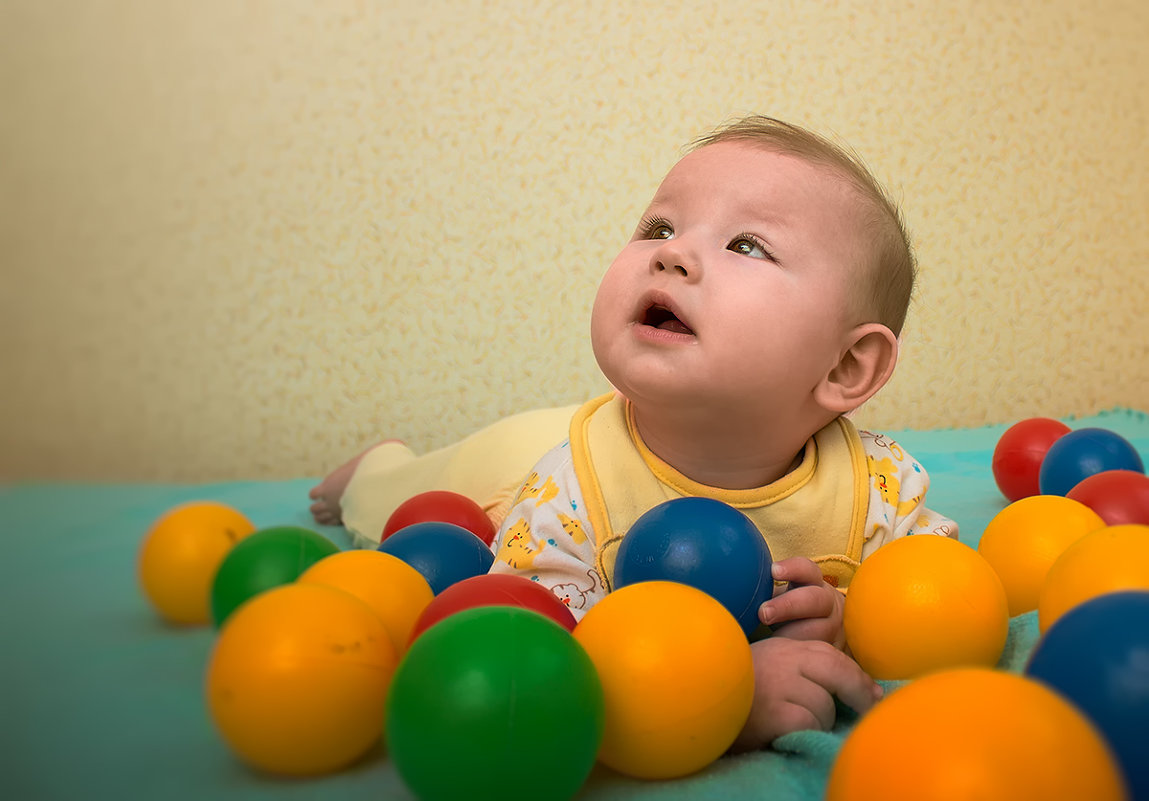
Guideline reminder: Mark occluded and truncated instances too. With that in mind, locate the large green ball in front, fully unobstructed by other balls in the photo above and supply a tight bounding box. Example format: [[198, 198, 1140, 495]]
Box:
[[386, 607, 603, 801]]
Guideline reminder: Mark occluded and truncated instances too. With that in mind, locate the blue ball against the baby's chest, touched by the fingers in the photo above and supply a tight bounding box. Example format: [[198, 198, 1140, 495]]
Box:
[[615, 498, 774, 636]]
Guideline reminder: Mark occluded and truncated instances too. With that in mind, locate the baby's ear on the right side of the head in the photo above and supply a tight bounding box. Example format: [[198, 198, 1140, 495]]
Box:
[[813, 323, 897, 414]]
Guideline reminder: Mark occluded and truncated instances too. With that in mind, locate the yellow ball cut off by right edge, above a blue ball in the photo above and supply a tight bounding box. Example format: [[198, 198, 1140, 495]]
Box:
[[1038, 523, 1149, 633]]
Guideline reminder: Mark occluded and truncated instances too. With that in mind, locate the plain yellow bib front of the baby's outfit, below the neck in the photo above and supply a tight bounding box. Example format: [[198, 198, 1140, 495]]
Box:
[[571, 394, 870, 592]]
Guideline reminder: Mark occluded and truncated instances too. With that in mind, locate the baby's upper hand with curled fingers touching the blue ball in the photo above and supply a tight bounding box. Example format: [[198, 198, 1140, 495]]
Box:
[[758, 556, 846, 650]]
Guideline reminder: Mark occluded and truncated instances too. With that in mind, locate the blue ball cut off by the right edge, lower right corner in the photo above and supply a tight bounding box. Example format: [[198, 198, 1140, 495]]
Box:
[[1026, 592, 1149, 799]]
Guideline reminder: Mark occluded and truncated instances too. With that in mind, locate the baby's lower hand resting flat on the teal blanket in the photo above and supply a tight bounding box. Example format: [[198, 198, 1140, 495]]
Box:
[[733, 638, 882, 752]]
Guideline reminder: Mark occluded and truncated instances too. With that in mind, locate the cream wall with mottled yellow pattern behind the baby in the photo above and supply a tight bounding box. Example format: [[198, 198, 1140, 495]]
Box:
[[0, 0, 1149, 480]]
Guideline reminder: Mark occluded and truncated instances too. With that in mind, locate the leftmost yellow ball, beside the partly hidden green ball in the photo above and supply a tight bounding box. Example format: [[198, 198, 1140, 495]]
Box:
[[137, 501, 255, 624]]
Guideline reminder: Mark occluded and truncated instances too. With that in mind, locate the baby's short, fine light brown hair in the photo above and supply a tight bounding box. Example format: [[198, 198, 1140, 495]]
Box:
[[689, 115, 917, 336]]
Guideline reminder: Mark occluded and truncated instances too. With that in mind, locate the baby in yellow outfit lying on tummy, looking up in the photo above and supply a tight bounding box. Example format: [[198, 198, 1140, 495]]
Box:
[[313, 116, 957, 749]]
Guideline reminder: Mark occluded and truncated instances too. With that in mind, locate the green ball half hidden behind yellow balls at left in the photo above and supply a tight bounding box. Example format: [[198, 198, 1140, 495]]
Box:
[[211, 525, 339, 626]]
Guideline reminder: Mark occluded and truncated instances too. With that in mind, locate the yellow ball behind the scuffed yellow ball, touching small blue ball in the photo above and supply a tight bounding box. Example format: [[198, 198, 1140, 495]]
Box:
[[299, 550, 434, 655]]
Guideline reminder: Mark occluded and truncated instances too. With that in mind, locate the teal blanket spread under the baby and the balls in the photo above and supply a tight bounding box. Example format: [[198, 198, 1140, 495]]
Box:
[[0, 410, 1149, 801]]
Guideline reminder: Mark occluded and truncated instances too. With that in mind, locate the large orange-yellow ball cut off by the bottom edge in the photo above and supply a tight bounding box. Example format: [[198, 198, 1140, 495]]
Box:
[[825, 666, 1126, 801]]
